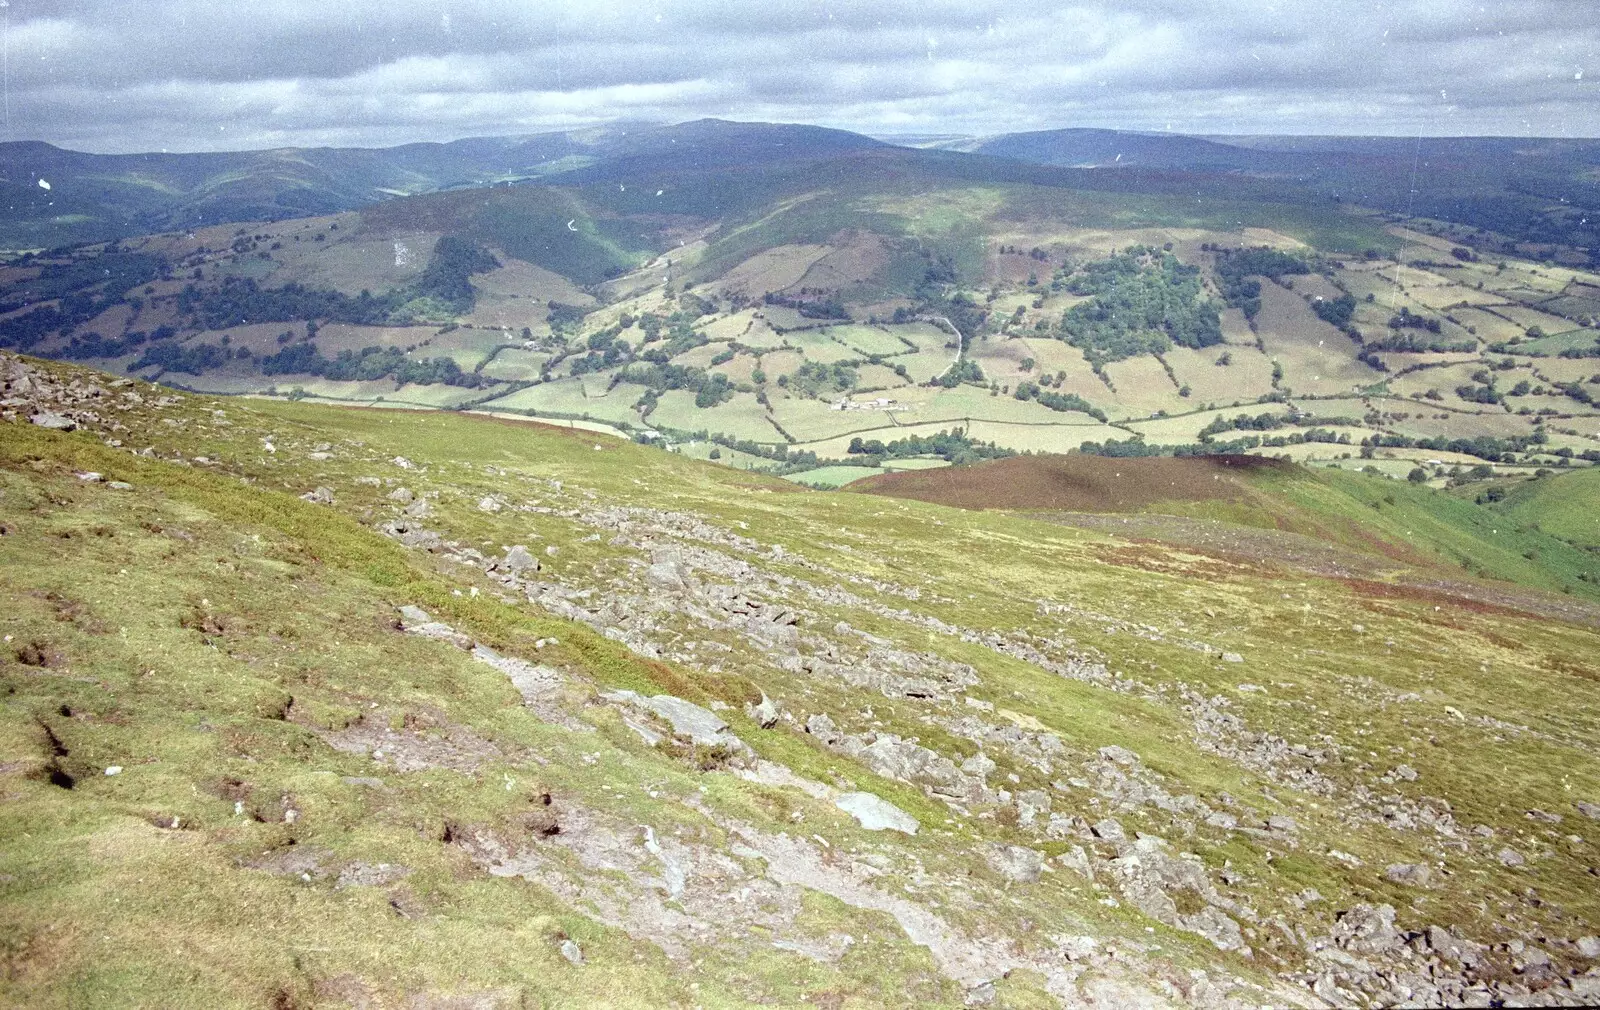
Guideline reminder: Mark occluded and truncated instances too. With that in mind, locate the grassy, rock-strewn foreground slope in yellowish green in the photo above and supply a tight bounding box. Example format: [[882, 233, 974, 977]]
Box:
[[0, 359, 1600, 1007]]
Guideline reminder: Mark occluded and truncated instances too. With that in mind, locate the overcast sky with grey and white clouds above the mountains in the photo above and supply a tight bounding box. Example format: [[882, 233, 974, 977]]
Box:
[[0, 0, 1600, 152]]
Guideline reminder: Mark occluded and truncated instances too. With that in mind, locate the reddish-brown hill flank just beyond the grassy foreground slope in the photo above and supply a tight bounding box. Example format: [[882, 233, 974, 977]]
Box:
[[850, 456, 1298, 512]]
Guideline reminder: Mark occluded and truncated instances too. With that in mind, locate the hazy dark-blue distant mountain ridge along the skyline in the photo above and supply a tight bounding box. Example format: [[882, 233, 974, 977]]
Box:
[[0, 118, 1600, 251]]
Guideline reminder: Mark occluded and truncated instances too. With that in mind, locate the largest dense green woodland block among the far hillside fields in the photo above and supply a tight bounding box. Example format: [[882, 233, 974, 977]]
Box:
[[1061, 246, 1222, 370]]
